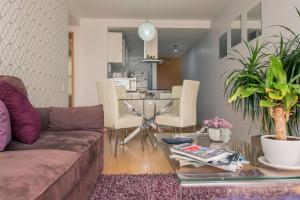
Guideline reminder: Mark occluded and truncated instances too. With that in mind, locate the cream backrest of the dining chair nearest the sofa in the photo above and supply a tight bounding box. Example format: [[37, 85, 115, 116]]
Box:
[[97, 79, 120, 128]]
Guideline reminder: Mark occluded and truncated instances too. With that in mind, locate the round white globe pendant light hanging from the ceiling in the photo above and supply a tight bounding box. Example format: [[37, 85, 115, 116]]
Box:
[[138, 0, 157, 42]]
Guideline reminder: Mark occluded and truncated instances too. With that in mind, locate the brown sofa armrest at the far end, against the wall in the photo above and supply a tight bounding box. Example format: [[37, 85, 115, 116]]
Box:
[[48, 105, 104, 131]]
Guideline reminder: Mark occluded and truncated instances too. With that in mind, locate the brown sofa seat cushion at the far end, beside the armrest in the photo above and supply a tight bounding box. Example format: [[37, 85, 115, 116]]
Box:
[[6, 131, 103, 177]]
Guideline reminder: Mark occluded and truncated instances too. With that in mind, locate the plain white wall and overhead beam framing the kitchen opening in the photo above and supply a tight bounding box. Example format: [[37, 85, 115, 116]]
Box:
[[69, 19, 210, 106]]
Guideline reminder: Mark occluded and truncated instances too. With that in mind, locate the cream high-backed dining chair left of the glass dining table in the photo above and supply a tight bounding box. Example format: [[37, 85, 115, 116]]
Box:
[[96, 79, 143, 156]]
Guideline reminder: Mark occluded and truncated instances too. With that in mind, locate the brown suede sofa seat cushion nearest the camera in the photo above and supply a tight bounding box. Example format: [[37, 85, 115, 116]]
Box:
[[0, 150, 80, 200]]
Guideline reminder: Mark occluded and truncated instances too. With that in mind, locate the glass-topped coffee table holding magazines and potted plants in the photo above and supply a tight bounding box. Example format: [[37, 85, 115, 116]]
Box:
[[155, 133, 300, 186]]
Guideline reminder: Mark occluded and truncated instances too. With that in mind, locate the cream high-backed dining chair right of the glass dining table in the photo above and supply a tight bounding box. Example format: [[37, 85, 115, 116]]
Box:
[[155, 80, 200, 132]]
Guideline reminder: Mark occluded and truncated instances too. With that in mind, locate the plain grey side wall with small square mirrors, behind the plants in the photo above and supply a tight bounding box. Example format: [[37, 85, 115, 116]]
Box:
[[183, 0, 300, 141]]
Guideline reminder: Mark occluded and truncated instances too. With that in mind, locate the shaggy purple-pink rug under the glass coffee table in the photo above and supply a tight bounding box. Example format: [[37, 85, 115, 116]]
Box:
[[89, 174, 300, 200]]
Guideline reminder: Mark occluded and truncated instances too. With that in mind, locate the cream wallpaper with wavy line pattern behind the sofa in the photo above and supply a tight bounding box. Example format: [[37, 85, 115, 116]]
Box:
[[0, 0, 68, 106]]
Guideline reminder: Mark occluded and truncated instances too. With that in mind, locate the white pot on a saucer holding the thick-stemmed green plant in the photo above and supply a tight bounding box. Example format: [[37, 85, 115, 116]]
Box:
[[261, 135, 300, 167]]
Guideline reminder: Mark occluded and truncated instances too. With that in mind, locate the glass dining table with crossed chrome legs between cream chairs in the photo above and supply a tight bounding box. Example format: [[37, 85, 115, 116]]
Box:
[[119, 95, 180, 147]]
